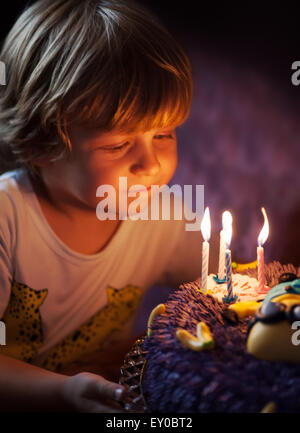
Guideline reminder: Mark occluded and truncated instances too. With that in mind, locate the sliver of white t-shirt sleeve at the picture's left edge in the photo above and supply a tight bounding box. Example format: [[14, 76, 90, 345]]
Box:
[[0, 191, 15, 319]]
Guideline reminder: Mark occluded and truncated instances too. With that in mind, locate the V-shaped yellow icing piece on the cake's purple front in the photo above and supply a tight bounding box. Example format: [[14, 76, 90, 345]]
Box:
[[176, 322, 215, 351]]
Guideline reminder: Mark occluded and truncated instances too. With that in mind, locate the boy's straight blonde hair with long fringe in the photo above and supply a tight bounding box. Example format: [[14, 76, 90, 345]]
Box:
[[0, 0, 192, 176]]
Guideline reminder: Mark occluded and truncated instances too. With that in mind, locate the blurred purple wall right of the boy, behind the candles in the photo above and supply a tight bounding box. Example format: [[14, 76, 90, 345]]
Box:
[[171, 45, 300, 265]]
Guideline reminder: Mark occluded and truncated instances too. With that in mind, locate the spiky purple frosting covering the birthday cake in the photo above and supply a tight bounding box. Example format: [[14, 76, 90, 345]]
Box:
[[142, 283, 300, 413]]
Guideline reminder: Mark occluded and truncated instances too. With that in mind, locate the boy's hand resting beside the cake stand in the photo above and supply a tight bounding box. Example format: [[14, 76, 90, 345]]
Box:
[[61, 372, 126, 413]]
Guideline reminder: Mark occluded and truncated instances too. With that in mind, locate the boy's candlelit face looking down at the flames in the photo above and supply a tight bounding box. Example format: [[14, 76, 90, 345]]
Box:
[[37, 125, 177, 210]]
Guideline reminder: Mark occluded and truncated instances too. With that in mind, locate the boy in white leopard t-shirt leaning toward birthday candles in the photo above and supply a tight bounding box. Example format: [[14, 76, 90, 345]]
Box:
[[0, 0, 217, 412]]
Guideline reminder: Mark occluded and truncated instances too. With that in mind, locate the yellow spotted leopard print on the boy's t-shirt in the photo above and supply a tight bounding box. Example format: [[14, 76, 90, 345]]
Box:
[[0, 281, 142, 371]]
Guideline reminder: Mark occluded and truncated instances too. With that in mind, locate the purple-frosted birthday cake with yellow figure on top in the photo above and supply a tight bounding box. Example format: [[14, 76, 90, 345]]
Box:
[[141, 262, 300, 413]]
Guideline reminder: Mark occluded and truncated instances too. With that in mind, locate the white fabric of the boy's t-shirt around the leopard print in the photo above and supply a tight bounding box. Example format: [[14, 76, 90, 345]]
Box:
[[0, 169, 217, 365]]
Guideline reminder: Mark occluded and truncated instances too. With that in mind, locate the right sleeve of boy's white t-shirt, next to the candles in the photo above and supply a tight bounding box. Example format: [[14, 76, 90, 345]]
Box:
[[157, 198, 218, 287]]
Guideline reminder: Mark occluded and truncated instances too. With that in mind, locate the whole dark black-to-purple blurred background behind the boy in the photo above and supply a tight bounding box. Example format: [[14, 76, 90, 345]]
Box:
[[0, 0, 300, 265]]
